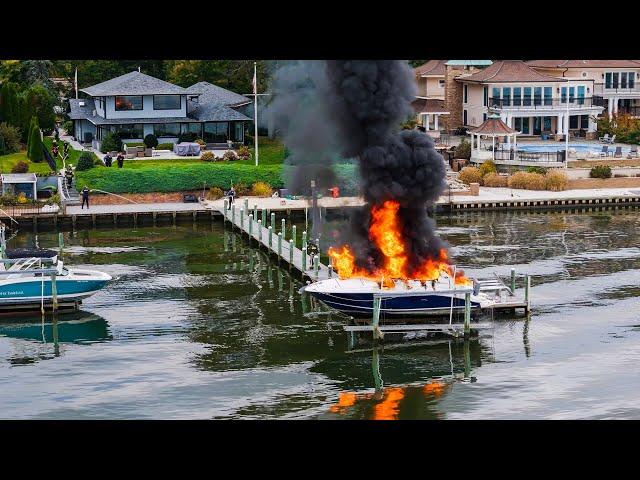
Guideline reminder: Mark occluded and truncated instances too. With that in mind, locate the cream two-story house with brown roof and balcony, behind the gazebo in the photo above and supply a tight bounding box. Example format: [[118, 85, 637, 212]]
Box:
[[456, 60, 603, 139]]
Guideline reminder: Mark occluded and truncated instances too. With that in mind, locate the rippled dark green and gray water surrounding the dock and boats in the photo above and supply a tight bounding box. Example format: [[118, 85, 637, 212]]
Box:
[[0, 211, 640, 419]]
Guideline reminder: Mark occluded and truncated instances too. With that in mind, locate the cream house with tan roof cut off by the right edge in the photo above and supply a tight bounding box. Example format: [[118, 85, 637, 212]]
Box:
[[527, 60, 640, 118]]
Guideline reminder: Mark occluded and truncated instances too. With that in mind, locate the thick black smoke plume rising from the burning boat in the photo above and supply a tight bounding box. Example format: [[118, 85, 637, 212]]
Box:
[[326, 60, 446, 273]]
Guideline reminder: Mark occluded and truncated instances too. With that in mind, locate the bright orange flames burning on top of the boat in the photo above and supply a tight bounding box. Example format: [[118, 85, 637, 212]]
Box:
[[328, 200, 471, 287]]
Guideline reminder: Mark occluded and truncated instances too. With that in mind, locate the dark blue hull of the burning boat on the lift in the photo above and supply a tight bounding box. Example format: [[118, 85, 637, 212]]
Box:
[[309, 292, 480, 317]]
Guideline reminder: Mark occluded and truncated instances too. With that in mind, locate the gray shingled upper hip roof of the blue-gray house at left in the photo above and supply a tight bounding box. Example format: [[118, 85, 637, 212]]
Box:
[[80, 71, 191, 97]]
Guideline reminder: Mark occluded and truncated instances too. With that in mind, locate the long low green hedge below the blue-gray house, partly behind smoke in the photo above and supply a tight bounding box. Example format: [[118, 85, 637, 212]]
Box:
[[77, 163, 358, 195]]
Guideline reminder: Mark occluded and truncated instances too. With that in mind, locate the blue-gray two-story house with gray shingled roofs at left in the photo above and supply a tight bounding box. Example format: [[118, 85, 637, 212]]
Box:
[[69, 71, 251, 149]]
